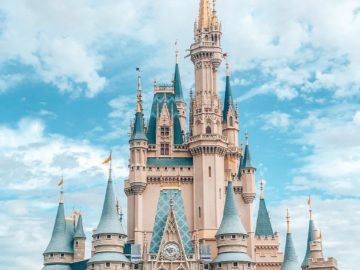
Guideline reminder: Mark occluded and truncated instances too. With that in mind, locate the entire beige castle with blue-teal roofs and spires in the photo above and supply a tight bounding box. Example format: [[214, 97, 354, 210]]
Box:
[[43, 0, 338, 270]]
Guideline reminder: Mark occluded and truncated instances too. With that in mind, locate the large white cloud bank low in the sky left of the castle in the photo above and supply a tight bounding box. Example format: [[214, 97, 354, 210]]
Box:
[[0, 118, 128, 270]]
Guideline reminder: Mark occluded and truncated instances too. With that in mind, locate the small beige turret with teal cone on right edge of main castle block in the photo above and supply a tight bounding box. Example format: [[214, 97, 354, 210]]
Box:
[[240, 130, 256, 203]]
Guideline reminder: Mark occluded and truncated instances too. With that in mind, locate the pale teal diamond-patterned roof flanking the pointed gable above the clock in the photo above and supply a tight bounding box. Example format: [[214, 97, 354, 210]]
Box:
[[149, 189, 194, 254]]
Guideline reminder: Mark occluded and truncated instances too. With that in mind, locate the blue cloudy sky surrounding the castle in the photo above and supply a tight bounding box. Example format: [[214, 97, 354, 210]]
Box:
[[0, 0, 360, 270]]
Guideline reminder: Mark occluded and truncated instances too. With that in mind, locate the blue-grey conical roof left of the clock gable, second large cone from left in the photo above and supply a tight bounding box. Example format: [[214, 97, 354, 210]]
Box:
[[95, 179, 126, 235]]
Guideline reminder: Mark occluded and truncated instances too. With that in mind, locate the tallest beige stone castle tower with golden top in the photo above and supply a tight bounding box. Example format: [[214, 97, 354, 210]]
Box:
[[189, 0, 227, 255]]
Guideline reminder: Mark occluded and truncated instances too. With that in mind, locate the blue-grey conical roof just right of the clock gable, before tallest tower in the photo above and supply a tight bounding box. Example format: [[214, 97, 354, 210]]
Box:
[[216, 181, 247, 236]]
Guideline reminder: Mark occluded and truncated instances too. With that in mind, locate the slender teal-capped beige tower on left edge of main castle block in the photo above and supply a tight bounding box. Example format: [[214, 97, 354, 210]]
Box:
[[127, 75, 148, 243]]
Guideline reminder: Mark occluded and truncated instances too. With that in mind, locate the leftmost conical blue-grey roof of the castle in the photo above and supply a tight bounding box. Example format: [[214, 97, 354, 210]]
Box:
[[44, 202, 74, 254]]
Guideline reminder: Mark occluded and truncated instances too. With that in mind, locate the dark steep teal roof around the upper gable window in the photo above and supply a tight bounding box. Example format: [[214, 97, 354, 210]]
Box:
[[146, 92, 184, 144]]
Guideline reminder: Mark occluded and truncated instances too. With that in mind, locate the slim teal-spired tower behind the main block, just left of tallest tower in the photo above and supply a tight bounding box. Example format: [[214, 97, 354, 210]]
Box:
[[174, 49, 186, 136]]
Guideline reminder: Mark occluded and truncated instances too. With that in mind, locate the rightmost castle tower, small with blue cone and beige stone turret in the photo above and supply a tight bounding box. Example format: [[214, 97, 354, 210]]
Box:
[[301, 202, 338, 270]]
